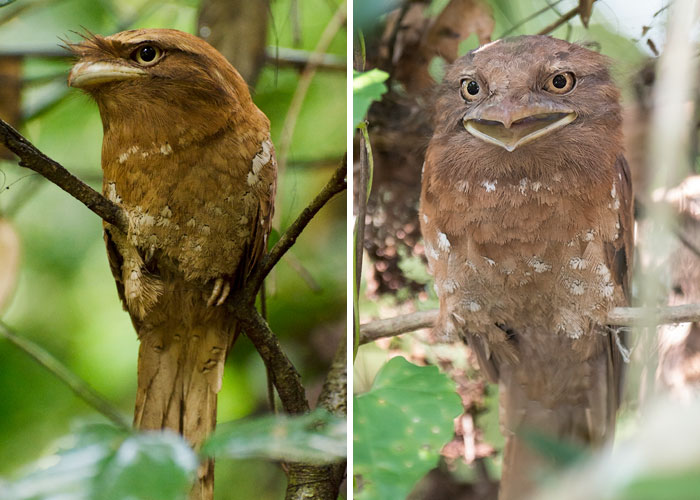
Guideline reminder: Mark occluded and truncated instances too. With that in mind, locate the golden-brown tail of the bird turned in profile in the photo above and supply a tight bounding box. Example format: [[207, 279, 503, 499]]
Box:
[[134, 324, 231, 500]]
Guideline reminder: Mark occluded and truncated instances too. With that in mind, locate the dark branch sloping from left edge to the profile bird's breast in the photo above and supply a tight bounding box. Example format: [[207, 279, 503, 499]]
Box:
[[0, 119, 128, 233]]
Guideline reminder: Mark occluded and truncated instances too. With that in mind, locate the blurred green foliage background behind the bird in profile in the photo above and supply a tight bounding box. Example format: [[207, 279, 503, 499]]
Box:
[[0, 0, 346, 500]]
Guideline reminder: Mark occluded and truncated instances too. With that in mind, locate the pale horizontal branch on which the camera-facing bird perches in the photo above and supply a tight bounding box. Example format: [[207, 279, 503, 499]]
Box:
[[360, 304, 700, 344]]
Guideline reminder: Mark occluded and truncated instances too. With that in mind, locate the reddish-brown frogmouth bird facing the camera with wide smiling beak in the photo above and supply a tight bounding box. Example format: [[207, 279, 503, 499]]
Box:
[[419, 36, 633, 499]]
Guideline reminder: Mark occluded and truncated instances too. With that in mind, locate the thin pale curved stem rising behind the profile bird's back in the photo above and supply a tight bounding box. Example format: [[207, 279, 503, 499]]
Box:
[[277, 2, 347, 177]]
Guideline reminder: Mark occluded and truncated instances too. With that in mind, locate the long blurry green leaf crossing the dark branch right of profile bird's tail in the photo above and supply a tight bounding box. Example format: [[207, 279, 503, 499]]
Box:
[[202, 409, 347, 464]]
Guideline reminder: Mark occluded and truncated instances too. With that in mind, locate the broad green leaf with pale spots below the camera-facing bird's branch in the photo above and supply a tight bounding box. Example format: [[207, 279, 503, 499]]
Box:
[[353, 357, 462, 500]]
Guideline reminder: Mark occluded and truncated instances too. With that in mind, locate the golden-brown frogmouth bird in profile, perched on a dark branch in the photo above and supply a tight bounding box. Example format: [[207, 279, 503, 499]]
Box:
[[68, 29, 277, 498]]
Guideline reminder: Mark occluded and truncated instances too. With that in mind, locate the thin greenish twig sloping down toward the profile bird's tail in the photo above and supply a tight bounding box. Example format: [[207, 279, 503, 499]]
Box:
[[0, 321, 131, 430]]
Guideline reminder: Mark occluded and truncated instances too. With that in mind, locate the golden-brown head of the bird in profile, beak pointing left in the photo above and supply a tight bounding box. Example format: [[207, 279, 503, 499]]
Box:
[[66, 29, 257, 143]]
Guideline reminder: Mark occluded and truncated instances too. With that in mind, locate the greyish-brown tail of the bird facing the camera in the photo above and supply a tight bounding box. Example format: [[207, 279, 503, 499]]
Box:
[[498, 334, 620, 500]]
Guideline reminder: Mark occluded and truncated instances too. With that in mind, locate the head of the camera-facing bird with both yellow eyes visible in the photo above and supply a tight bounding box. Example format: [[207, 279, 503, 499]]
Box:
[[436, 36, 620, 160]]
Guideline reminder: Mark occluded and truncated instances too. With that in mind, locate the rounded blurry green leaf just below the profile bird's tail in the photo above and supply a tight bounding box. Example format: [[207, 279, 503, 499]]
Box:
[[91, 431, 197, 500]]
